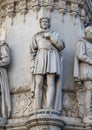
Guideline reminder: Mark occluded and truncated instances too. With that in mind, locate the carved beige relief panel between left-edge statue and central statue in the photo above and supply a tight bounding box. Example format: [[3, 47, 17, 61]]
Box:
[[11, 91, 33, 118]]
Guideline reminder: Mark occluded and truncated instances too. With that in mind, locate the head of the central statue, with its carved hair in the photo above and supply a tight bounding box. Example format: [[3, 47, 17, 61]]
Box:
[[40, 17, 50, 29]]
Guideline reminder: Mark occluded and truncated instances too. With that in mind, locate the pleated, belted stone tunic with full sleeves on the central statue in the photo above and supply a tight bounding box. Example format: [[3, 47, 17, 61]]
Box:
[[31, 31, 64, 75]]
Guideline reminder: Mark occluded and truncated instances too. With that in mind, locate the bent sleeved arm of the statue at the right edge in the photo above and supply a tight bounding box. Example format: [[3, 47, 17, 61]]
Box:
[[76, 41, 92, 65]]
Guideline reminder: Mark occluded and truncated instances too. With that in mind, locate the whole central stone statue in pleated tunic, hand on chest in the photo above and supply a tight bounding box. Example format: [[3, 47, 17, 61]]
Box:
[[30, 17, 65, 111]]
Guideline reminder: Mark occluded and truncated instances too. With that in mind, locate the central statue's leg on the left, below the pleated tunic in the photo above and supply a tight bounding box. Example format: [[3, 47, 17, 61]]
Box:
[[35, 75, 43, 109]]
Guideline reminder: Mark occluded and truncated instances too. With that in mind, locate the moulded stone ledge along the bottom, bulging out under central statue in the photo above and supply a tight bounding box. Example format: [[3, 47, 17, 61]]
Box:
[[5, 115, 92, 130]]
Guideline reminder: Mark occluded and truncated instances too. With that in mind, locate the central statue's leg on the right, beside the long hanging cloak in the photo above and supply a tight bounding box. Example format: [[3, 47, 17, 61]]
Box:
[[47, 74, 55, 109]]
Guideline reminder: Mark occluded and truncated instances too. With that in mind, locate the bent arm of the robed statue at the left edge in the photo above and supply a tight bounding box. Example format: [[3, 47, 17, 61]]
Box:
[[0, 44, 10, 67]]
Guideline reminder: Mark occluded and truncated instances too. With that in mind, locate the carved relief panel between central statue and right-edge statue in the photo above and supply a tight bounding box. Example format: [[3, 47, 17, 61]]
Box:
[[62, 92, 79, 118]]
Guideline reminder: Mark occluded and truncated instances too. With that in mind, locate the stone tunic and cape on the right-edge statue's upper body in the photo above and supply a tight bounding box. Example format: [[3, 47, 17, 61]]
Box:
[[74, 39, 92, 81]]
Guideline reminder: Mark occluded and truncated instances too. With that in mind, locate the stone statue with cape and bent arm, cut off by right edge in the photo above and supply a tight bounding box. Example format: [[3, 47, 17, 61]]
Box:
[[74, 25, 92, 122]]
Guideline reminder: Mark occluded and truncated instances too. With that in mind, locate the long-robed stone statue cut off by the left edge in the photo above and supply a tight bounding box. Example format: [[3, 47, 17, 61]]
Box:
[[0, 40, 11, 118]]
